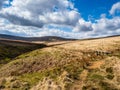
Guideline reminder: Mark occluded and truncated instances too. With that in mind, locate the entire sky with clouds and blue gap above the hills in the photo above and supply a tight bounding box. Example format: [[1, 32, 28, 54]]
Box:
[[0, 0, 120, 38]]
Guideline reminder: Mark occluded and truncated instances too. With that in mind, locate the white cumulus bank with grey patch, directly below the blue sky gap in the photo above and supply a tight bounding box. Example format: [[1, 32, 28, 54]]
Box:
[[73, 15, 120, 38]]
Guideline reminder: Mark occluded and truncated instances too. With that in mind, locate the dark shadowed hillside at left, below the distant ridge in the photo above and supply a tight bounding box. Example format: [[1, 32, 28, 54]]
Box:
[[0, 41, 46, 64]]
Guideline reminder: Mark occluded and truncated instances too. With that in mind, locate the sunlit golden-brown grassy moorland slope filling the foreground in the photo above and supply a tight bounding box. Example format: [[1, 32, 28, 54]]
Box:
[[0, 37, 120, 90]]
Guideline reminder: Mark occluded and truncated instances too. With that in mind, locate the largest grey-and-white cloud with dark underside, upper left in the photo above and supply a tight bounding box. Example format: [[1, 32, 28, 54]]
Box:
[[0, 0, 80, 28]]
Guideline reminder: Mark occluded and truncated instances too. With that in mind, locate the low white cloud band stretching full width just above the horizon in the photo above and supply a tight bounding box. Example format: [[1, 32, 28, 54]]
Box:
[[0, 14, 120, 38]]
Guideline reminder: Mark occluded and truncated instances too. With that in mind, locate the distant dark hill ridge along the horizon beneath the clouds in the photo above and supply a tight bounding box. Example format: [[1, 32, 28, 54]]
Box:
[[0, 34, 75, 42]]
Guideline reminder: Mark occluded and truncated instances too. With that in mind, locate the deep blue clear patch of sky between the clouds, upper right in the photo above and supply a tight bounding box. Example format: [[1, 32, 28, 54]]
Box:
[[73, 0, 120, 20]]
